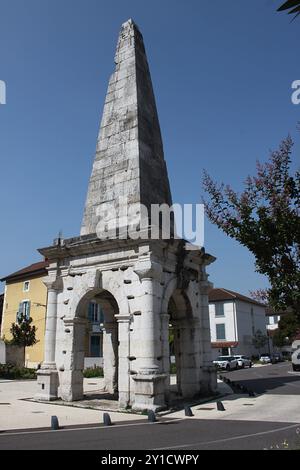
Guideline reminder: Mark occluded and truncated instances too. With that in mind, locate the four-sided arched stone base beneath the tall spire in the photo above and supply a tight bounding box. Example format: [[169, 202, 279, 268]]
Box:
[[38, 238, 216, 410]]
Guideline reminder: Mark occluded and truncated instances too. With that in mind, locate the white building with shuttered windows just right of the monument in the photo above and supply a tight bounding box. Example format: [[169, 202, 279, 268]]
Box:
[[209, 289, 269, 359]]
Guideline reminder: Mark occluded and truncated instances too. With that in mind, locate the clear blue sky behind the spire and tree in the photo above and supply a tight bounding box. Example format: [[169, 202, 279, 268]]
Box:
[[0, 0, 300, 294]]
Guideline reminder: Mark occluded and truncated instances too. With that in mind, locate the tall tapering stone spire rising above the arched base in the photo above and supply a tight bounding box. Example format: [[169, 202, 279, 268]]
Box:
[[81, 20, 172, 235]]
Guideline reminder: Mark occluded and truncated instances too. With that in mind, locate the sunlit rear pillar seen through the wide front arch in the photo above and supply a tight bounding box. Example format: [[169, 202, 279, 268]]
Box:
[[103, 322, 118, 395]]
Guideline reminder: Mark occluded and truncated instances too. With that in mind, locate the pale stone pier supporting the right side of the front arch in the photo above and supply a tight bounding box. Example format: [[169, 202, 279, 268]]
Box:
[[115, 315, 133, 408]]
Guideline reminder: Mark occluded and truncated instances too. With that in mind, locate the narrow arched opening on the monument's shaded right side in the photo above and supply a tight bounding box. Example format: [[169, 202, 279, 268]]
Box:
[[168, 290, 192, 403]]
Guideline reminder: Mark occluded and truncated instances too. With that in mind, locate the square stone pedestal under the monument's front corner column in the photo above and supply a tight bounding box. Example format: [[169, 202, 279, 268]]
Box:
[[132, 374, 168, 411]]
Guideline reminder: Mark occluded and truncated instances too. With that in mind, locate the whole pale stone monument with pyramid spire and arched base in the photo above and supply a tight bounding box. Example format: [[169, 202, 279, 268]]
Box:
[[37, 20, 216, 411]]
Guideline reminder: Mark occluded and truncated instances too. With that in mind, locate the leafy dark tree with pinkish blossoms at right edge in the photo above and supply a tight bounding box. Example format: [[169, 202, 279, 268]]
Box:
[[203, 137, 300, 318]]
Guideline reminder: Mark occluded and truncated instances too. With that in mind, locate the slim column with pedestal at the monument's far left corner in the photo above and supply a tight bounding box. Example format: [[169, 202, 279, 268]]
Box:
[[36, 281, 58, 401]]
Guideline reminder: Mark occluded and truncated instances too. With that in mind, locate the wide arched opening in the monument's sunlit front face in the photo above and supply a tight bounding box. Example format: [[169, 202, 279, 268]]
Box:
[[74, 289, 119, 400]]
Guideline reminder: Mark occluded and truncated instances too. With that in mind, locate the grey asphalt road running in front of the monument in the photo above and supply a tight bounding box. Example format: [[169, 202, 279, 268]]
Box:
[[0, 364, 300, 452]]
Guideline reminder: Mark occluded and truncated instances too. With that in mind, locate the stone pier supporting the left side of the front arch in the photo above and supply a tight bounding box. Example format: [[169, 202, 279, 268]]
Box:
[[59, 318, 87, 401]]
